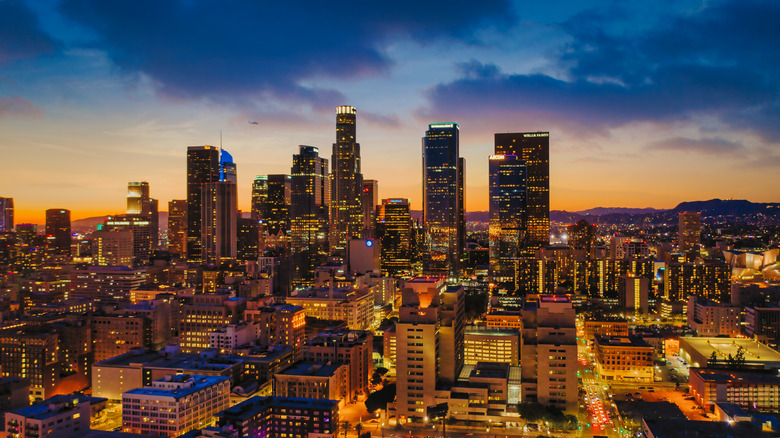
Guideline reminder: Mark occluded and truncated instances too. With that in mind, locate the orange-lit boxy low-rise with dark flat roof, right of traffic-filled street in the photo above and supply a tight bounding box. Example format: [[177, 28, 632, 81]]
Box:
[[595, 336, 654, 382]]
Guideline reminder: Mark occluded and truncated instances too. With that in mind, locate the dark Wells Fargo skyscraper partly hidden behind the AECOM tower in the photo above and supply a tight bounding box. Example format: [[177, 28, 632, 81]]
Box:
[[495, 132, 550, 257]]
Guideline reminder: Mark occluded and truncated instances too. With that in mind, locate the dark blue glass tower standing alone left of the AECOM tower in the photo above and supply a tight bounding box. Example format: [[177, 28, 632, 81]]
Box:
[[422, 123, 465, 276]]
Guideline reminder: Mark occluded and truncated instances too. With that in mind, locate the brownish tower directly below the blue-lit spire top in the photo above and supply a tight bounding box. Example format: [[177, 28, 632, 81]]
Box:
[[200, 181, 238, 265]]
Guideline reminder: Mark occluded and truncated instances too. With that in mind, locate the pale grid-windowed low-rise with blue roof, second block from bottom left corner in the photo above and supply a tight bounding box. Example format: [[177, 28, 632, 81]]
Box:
[[122, 374, 230, 437]]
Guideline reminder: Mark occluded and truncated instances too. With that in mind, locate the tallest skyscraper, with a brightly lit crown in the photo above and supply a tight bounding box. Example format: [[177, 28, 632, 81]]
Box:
[[330, 106, 363, 254]]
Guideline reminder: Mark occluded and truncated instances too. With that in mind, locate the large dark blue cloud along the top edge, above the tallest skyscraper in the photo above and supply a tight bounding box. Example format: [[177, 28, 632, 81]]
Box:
[[62, 0, 511, 105]]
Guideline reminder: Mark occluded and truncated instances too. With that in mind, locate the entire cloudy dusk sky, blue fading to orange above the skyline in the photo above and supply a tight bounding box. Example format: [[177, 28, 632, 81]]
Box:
[[0, 0, 780, 223]]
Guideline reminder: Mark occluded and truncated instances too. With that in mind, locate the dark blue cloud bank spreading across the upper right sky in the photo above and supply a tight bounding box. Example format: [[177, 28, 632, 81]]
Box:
[[425, 1, 780, 140]]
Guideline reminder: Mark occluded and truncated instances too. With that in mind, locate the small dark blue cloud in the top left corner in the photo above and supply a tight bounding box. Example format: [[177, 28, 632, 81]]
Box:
[[0, 0, 57, 62]]
